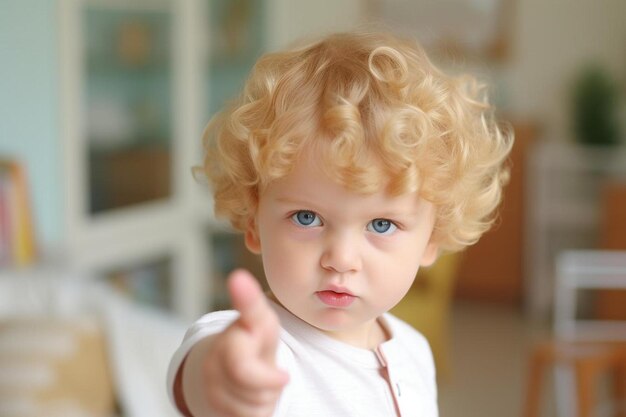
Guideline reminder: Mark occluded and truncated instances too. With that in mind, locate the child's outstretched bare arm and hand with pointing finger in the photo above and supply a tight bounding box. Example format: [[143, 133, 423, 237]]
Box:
[[174, 271, 288, 417]]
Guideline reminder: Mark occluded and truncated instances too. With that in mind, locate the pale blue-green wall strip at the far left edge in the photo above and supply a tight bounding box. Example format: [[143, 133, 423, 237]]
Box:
[[0, 0, 63, 246]]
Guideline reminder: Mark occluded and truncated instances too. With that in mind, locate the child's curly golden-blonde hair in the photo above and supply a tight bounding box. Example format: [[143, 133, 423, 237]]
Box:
[[204, 32, 513, 251]]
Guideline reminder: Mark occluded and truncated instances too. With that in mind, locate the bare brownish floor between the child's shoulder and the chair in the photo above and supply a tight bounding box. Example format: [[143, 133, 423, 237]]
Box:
[[439, 302, 554, 417]]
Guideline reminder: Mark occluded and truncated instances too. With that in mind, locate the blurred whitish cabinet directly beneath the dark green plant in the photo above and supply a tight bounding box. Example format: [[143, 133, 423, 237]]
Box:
[[524, 142, 626, 318]]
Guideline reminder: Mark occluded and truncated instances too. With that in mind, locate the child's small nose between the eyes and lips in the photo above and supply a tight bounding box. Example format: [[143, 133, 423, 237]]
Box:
[[320, 233, 362, 273]]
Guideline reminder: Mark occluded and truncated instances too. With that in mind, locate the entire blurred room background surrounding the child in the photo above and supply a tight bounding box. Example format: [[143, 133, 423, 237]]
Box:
[[0, 0, 626, 417]]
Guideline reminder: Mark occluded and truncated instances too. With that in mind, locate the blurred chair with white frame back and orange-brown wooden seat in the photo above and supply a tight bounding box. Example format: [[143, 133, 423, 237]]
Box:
[[524, 251, 626, 417]]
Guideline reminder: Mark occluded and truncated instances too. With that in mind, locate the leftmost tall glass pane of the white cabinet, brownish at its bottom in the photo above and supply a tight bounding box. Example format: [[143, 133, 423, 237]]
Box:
[[81, 1, 173, 215]]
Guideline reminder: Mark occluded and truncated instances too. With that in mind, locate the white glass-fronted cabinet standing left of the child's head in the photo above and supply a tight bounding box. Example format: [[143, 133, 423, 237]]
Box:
[[59, 0, 213, 318]]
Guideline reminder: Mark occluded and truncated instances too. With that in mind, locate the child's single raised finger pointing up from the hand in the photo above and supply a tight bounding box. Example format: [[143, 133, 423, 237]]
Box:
[[228, 269, 279, 361]]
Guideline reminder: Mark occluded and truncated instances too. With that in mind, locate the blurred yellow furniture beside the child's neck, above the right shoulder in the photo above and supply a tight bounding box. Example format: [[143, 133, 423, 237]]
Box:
[[391, 253, 461, 379]]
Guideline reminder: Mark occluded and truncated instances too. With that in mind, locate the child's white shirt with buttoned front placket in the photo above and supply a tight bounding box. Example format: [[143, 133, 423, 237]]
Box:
[[167, 303, 438, 417]]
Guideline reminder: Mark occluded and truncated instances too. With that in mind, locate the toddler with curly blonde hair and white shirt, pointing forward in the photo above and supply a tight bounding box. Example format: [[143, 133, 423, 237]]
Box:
[[168, 32, 512, 417]]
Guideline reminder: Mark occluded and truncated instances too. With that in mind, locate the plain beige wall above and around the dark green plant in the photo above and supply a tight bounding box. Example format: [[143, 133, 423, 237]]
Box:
[[506, 0, 626, 140]]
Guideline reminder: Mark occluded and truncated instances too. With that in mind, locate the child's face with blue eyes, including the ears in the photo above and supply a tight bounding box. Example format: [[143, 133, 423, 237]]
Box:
[[241, 151, 437, 347]]
